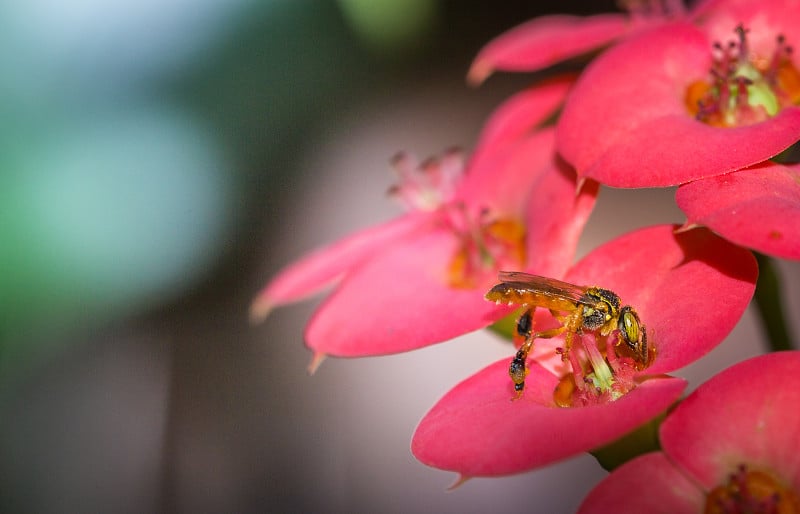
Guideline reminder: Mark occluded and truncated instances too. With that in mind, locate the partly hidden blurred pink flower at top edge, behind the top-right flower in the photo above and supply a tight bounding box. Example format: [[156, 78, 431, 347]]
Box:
[[467, 0, 687, 84]]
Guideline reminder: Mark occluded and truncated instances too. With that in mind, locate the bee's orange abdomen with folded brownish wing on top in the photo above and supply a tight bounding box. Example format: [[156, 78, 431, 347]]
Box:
[[486, 271, 586, 308]]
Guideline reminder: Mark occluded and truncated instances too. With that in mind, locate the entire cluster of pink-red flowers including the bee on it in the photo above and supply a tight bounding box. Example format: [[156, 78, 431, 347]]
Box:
[[252, 0, 800, 512]]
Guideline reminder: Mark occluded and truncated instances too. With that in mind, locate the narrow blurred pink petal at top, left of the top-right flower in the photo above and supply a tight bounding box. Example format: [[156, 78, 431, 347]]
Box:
[[468, 14, 629, 83]]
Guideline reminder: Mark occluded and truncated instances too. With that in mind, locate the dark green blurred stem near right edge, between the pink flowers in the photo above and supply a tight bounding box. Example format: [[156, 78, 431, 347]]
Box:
[[753, 253, 793, 352]]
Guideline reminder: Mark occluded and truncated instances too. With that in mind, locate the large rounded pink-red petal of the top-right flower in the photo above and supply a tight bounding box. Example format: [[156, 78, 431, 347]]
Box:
[[557, 23, 800, 187]]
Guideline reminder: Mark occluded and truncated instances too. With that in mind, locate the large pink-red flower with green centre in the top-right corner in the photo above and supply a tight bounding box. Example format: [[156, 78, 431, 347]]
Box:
[[557, 0, 800, 187]]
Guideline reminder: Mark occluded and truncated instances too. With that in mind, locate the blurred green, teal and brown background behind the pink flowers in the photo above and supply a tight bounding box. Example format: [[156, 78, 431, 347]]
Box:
[[0, 0, 800, 513]]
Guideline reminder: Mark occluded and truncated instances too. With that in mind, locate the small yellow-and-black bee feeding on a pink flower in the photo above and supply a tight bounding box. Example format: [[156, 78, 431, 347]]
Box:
[[486, 271, 652, 396]]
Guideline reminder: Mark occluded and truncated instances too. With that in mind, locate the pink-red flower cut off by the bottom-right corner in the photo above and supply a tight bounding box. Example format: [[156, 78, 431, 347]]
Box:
[[579, 352, 800, 514]]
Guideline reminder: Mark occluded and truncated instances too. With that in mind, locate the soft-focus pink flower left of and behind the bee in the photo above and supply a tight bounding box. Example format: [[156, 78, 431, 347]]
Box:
[[252, 80, 597, 362]]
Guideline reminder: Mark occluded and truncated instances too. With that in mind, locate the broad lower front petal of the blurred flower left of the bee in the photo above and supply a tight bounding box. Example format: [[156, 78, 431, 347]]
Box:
[[305, 229, 502, 357]]
